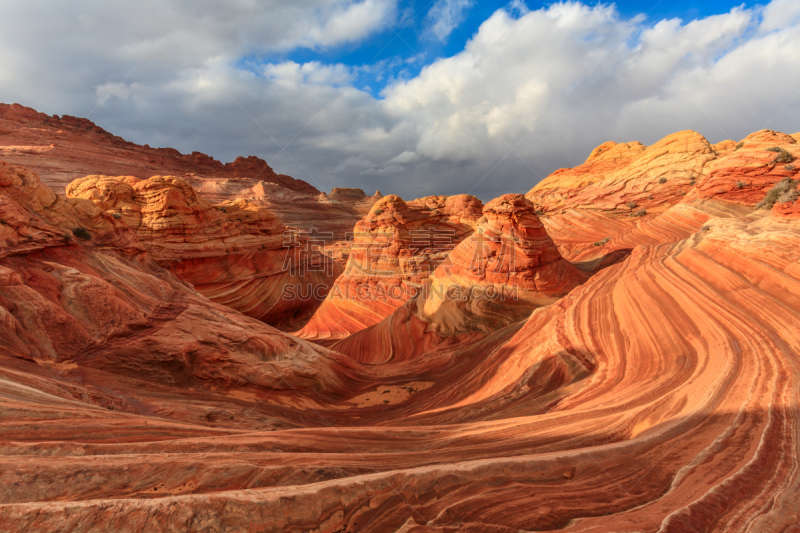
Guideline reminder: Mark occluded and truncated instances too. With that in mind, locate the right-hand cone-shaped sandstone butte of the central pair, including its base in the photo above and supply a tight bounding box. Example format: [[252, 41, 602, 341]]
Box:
[[328, 194, 587, 364]]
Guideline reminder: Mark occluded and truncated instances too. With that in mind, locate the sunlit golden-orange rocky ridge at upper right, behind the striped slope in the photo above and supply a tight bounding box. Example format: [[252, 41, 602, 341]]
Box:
[[527, 130, 800, 264]]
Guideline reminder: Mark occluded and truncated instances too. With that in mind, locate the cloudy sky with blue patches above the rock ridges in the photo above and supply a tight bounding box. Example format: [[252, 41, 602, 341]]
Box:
[[0, 0, 800, 200]]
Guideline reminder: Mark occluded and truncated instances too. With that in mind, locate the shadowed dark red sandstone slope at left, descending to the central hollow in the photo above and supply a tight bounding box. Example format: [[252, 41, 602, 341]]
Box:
[[0, 164, 356, 416]]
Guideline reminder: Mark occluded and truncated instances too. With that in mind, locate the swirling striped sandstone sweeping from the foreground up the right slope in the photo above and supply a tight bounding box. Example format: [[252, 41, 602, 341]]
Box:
[[0, 198, 800, 533]]
